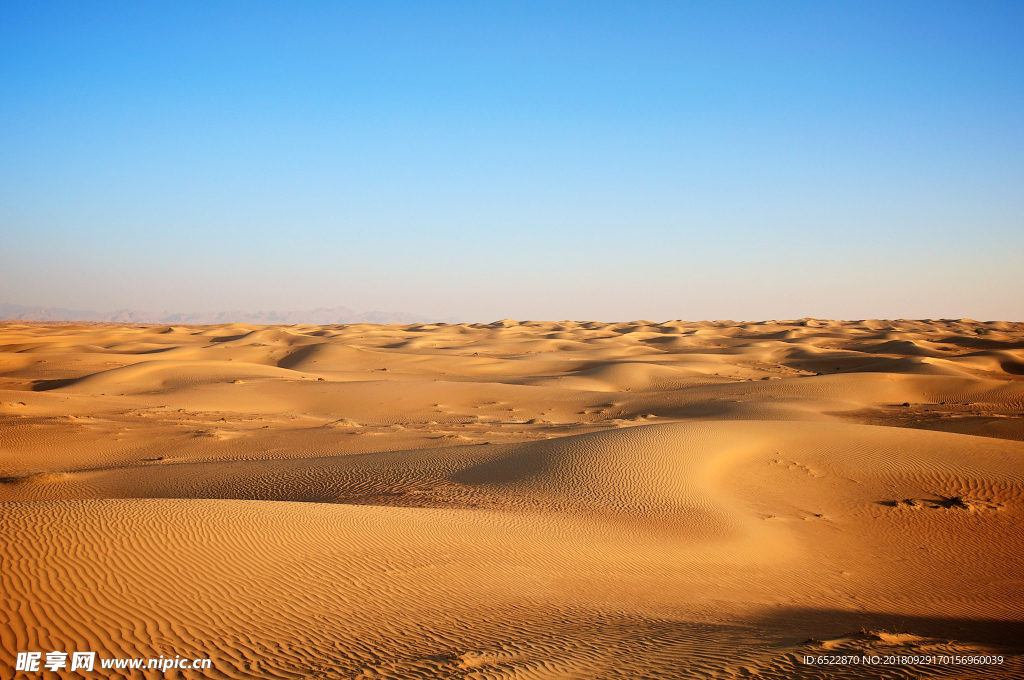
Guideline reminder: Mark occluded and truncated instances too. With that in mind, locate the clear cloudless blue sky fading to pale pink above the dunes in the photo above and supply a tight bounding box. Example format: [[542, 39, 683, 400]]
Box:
[[0, 0, 1024, 321]]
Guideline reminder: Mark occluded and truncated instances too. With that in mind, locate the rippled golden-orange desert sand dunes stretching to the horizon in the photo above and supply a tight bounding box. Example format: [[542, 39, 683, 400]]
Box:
[[0, 320, 1024, 679]]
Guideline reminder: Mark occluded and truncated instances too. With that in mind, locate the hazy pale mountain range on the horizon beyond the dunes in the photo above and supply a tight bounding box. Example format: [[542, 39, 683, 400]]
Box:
[[0, 304, 438, 326]]
